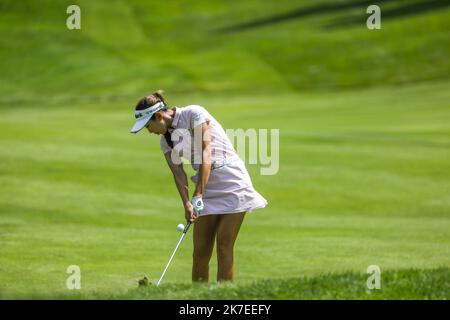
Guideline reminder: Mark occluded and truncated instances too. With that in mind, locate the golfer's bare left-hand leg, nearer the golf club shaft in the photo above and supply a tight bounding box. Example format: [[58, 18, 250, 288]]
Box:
[[192, 214, 219, 281]]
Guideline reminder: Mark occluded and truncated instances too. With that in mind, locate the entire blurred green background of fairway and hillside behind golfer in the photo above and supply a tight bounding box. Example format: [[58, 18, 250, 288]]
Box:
[[0, 0, 450, 299]]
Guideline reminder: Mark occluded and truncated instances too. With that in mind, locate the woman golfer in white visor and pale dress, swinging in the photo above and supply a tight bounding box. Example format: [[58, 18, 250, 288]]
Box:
[[131, 91, 267, 281]]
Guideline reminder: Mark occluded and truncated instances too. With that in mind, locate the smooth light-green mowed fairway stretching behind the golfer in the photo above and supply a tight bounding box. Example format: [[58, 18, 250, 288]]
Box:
[[0, 83, 450, 298]]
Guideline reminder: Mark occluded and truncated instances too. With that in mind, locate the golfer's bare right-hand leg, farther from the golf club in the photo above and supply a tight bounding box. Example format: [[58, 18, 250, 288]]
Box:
[[217, 212, 245, 281]]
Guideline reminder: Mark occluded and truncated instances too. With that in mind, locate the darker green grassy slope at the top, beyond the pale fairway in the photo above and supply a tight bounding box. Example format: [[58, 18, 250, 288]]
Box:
[[0, 0, 450, 103]]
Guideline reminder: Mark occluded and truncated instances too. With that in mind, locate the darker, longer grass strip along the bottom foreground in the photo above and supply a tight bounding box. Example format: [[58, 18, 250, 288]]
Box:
[[0, 268, 450, 300]]
